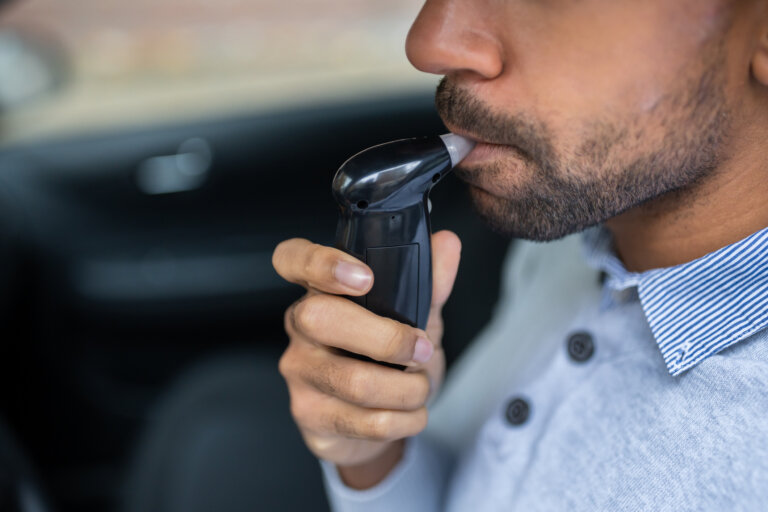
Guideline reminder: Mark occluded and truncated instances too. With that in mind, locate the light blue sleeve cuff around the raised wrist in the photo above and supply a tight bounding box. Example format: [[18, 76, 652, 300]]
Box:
[[320, 434, 452, 512]]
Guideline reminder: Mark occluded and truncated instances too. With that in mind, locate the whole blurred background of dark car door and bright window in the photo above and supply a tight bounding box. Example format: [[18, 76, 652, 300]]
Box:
[[0, 0, 508, 512]]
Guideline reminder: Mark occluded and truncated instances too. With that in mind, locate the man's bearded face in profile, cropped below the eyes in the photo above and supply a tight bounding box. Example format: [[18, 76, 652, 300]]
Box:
[[407, 0, 749, 240]]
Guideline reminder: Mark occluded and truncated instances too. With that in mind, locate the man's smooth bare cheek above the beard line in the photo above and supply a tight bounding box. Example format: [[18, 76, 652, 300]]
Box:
[[486, 0, 723, 138]]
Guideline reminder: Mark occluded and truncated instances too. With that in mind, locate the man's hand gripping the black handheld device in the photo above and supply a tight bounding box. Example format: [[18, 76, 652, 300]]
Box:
[[272, 231, 461, 488]]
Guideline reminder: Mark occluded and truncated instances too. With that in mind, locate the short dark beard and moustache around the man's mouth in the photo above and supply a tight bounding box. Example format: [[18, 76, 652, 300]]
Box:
[[435, 45, 729, 241]]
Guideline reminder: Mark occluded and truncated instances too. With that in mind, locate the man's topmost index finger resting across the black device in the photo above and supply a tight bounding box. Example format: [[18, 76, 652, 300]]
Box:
[[272, 238, 373, 296]]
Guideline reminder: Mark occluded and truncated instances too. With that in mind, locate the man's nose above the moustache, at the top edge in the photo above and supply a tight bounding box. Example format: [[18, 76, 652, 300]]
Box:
[[405, 0, 504, 80]]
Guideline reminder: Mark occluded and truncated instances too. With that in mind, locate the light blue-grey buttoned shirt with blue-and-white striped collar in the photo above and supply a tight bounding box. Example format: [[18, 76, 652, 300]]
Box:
[[322, 228, 768, 512]]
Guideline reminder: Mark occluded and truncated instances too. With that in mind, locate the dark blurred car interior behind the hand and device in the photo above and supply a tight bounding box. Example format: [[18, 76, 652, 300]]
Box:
[[0, 0, 509, 511]]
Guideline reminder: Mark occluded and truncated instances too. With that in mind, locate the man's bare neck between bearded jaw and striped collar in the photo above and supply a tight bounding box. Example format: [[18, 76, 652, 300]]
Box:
[[605, 136, 768, 272]]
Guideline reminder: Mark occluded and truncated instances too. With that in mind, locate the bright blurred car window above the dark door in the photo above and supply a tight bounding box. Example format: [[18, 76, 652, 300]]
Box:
[[0, 0, 436, 145]]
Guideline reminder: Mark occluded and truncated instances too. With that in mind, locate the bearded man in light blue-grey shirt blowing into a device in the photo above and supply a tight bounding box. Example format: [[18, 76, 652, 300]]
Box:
[[273, 0, 768, 511]]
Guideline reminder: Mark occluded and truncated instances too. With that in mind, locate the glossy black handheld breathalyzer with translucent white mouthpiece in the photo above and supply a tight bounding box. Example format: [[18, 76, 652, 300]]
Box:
[[333, 134, 475, 364]]
